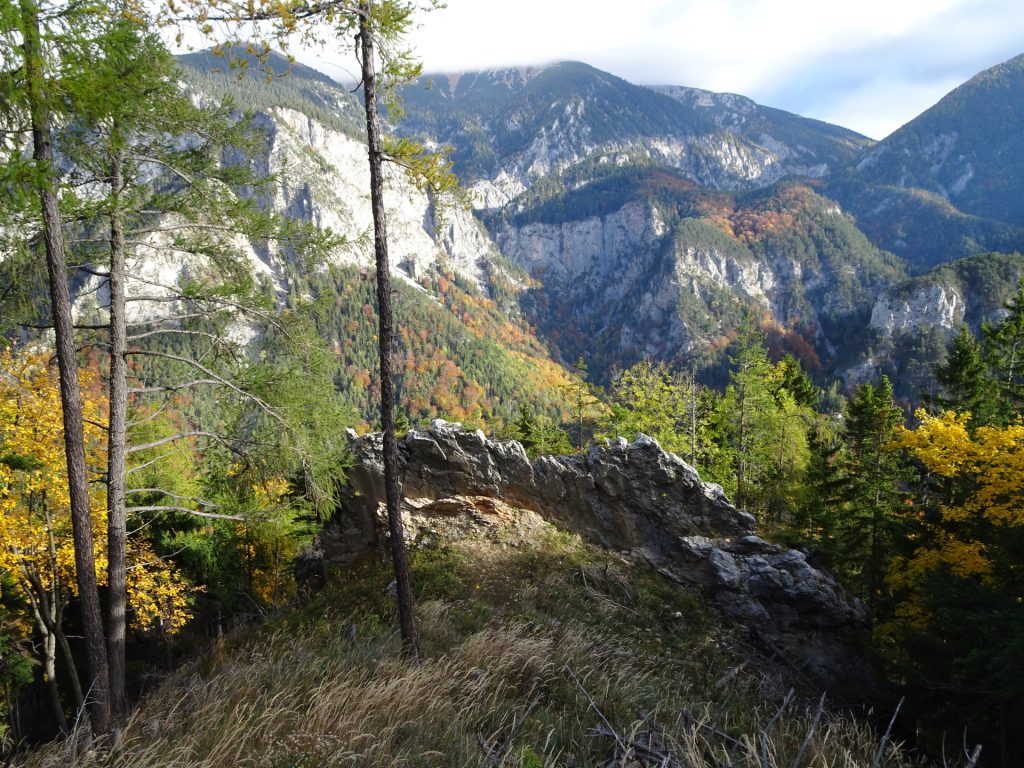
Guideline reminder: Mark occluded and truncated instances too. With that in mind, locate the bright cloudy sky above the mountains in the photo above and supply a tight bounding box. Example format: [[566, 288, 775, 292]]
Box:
[[309, 0, 1024, 138]]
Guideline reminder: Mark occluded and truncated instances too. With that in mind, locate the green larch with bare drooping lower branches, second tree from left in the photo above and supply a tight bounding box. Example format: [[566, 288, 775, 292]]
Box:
[[8, 4, 348, 723]]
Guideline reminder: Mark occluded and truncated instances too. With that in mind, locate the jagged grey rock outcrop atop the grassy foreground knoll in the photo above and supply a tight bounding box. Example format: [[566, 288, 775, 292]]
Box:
[[300, 421, 864, 683]]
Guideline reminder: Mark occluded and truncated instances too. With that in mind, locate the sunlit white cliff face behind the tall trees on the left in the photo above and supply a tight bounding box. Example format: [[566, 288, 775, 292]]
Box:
[[76, 101, 517, 322]]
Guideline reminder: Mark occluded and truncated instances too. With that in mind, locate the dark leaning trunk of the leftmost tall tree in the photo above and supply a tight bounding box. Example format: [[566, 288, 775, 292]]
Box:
[[20, 0, 110, 735]]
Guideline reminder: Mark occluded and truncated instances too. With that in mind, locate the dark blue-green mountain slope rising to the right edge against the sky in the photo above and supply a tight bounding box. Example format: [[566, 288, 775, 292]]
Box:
[[855, 54, 1024, 225]]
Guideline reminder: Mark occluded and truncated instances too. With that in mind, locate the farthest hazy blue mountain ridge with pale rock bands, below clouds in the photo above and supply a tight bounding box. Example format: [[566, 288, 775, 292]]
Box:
[[398, 61, 869, 208]]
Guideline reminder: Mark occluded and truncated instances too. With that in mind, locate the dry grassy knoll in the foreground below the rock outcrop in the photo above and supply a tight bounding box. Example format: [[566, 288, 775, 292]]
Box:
[[15, 531, 937, 768]]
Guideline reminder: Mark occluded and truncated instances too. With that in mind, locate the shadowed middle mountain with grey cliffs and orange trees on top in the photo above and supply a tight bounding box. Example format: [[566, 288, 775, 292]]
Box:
[[486, 165, 905, 385]]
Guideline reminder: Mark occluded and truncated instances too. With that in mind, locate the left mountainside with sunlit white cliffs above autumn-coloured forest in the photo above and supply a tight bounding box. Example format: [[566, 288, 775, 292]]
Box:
[[167, 53, 585, 427]]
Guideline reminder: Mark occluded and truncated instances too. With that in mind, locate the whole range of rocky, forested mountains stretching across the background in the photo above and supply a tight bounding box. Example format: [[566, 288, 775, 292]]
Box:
[[181, 49, 1024, 403]]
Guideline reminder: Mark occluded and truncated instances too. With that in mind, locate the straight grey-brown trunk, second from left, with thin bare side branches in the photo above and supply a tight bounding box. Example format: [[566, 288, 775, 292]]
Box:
[[106, 141, 128, 724]]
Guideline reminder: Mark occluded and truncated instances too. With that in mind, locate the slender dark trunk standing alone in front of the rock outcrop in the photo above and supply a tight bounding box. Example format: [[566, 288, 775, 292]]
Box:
[[359, 0, 420, 662]]
